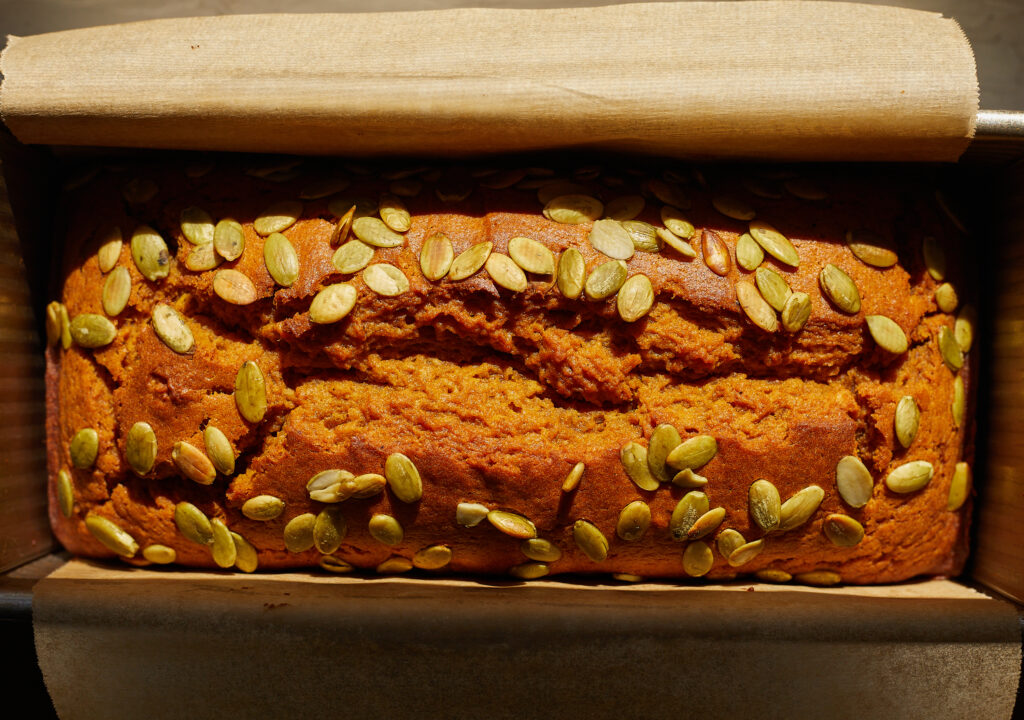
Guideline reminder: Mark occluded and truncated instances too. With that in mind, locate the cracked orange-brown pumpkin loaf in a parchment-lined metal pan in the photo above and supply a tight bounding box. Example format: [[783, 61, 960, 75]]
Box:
[[47, 160, 973, 584]]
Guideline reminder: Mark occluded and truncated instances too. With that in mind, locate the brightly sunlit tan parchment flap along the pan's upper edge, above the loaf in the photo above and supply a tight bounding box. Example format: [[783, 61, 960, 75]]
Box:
[[0, 1, 978, 161]]
